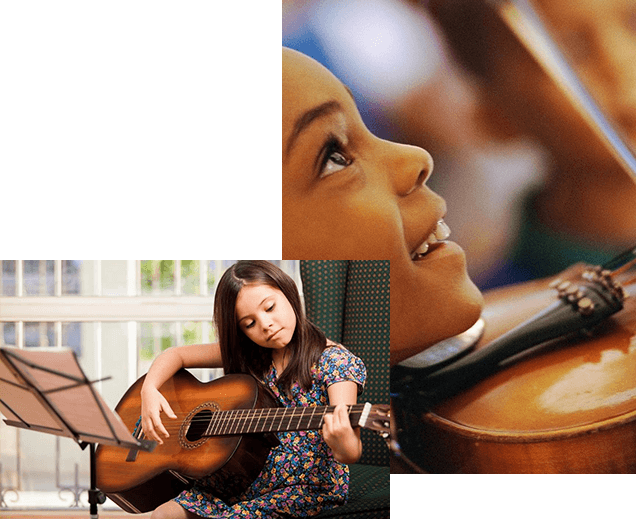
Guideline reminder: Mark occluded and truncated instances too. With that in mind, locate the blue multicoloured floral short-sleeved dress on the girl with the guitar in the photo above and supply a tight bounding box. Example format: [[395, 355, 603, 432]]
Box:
[[175, 345, 367, 518]]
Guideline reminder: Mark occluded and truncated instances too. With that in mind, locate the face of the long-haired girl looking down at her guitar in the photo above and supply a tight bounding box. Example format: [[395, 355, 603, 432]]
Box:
[[236, 285, 296, 350]]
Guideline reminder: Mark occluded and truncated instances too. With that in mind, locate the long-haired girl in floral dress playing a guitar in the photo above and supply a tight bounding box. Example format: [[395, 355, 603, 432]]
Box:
[[141, 260, 366, 519]]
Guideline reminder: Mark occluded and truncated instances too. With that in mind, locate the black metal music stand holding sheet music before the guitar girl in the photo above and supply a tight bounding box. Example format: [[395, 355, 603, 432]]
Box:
[[0, 348, 156, 519]]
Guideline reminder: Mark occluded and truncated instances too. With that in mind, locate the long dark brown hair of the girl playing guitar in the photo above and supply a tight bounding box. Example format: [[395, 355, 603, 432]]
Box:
[[214, 260, 327, 392]]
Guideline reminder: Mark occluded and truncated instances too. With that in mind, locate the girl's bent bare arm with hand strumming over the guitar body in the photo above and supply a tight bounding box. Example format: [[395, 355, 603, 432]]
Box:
[[141, 344, 223, 445]]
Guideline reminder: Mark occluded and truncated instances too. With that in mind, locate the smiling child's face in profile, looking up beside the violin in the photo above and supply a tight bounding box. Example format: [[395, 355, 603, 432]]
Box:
[[282, 48, 483, 363]]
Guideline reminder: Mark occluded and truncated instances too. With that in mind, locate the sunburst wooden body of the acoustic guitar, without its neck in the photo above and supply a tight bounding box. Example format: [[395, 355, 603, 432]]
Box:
[[97, 370, 278, 513]]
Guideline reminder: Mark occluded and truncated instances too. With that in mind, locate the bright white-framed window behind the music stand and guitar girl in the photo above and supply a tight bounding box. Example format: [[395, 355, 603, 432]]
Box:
[[0, 260, 300, 508]]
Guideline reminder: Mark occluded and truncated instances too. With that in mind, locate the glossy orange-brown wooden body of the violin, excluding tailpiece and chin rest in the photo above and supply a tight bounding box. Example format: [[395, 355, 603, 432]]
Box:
[[393, 268, 636, 473]]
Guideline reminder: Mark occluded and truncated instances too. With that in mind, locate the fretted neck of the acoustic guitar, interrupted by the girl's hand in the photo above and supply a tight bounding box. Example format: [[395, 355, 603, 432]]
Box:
[[203, 404, 371, 436]]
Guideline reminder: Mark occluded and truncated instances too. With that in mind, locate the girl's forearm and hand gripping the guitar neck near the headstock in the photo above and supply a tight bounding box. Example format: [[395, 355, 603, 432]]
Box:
[[322, 382, 362, 465]]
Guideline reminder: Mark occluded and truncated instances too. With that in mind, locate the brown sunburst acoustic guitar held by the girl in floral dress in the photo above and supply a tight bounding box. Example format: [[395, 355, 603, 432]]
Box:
[[96, 370, 390, 513]]
